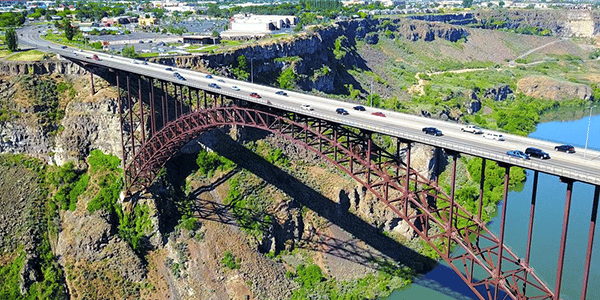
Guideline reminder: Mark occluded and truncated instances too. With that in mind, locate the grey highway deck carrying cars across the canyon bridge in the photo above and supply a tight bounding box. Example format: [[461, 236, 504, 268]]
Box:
[[18, 27, 600, 185]]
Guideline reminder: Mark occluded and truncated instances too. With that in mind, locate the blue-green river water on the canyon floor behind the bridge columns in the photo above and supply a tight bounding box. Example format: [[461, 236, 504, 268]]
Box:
[[387, 111, 600, 300]]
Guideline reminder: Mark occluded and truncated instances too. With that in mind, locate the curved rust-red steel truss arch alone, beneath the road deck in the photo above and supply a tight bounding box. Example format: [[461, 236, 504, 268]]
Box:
[[125, 106, 554, 299]]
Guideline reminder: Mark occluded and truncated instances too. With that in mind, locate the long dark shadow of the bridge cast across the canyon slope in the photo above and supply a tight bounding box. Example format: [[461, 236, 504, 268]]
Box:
[[183, 132, 477, 299]]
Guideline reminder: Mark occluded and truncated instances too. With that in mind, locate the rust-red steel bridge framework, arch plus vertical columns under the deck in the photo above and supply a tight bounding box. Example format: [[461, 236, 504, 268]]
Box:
[[92, 70, 600, 299]]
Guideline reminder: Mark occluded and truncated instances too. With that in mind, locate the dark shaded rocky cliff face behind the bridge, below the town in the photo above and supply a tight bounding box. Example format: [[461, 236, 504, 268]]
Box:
[[155, 19, 469, 94]]
